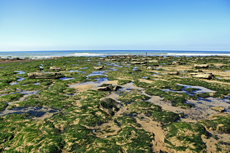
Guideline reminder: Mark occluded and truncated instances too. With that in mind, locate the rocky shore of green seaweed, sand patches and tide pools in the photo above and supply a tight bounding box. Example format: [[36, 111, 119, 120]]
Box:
[[0, 55, 230, 152]]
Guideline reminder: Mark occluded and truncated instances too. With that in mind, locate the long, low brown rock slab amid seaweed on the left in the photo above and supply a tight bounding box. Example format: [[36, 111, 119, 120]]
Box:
[[27, 72, 63, 79]]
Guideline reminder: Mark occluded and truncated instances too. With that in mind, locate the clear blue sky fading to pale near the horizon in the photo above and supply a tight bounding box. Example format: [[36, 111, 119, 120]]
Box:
[[0, 0, 230, 51]]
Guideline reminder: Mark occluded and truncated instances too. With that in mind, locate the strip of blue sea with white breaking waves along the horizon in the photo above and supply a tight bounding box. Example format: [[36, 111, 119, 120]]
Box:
[[0, 50, 230, 59]]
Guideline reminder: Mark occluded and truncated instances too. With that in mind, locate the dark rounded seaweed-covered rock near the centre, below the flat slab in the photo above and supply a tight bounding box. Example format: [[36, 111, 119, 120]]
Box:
[[100, 98, 119, 115]]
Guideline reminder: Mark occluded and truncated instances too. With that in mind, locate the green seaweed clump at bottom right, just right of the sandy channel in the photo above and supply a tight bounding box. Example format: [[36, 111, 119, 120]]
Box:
[[165, 122, 208, 152]]
